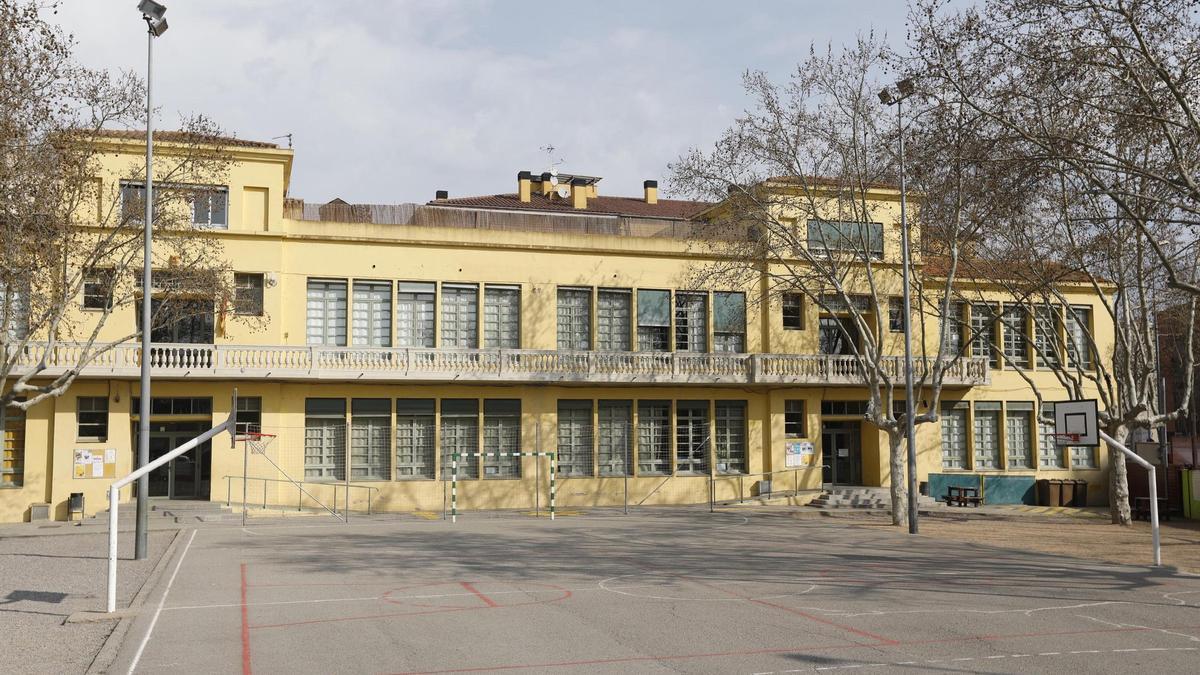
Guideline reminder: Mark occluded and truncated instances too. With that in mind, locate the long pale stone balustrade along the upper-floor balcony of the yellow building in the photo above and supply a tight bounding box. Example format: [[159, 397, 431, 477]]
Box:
[[8, 342, 990, 386]]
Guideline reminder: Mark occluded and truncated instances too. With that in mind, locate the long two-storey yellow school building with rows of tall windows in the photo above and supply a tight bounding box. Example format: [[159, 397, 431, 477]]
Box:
[[0, 132, 1112, 521]]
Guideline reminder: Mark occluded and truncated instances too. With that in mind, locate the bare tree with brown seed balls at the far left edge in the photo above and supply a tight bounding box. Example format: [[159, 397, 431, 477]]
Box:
[[0, 0, 243, 423]]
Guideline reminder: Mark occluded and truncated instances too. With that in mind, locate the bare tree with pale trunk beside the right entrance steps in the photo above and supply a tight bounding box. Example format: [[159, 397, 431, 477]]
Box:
[[671, 36, 977, 525]]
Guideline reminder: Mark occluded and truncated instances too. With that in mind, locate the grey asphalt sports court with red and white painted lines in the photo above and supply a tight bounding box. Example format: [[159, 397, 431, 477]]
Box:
[[112, 508, 1200, 674]]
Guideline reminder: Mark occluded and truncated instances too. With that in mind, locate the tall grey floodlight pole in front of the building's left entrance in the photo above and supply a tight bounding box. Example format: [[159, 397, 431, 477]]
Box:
[[133, 0, 167, 560]]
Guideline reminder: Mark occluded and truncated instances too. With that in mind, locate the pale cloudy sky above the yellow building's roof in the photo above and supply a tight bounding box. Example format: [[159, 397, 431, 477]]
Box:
[[56, 0, 905, 203]]
